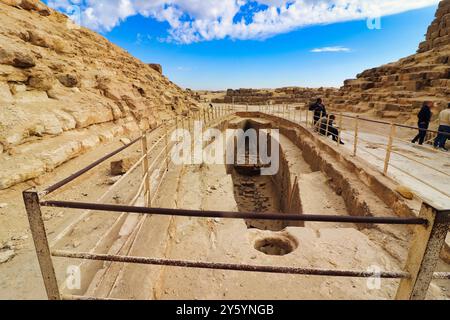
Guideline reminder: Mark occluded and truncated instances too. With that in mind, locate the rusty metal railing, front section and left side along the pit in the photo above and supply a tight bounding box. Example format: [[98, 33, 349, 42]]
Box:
[[23, 106, 450, 300]]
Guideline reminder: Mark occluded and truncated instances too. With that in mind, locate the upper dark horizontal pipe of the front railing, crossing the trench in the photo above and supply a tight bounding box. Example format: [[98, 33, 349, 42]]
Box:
[[37, 201, 428, 225]]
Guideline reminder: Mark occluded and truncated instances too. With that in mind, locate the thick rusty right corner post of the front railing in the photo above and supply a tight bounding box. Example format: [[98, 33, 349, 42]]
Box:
[[395, 203, 450, 300]]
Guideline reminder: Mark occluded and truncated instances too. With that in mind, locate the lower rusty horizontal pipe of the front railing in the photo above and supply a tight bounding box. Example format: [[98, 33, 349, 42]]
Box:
[[52, 250, 410, 279]]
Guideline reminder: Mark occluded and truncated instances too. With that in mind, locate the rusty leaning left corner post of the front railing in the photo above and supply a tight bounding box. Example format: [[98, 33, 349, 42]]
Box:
[[23, 189, 61, 300]]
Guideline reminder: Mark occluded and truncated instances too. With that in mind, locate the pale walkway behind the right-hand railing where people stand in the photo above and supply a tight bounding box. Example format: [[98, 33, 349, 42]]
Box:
[[237, 106, 450, 210]]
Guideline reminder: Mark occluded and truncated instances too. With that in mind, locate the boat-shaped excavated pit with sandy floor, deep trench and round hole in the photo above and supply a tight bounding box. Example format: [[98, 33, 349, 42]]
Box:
[[61, 113, 448, 299]]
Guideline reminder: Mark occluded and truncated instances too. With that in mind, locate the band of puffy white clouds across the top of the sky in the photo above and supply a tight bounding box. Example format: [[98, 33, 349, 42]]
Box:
[[48, 0, 439, 43]]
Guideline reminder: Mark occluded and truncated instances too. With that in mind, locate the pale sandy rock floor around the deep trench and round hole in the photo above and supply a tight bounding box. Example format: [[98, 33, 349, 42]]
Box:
[[72, 124, 445, 299]]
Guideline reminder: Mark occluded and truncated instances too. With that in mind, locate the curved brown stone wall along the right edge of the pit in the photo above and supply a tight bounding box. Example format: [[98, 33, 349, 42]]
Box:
[[237, 112, 420, 222]]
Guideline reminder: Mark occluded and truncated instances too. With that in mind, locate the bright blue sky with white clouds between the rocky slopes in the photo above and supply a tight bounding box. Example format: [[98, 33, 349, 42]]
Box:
[[46, 0, 439, 91]]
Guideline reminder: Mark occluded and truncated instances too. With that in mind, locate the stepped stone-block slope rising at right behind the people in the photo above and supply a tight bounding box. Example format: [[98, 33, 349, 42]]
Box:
[[332, 0, 450, 121]]
